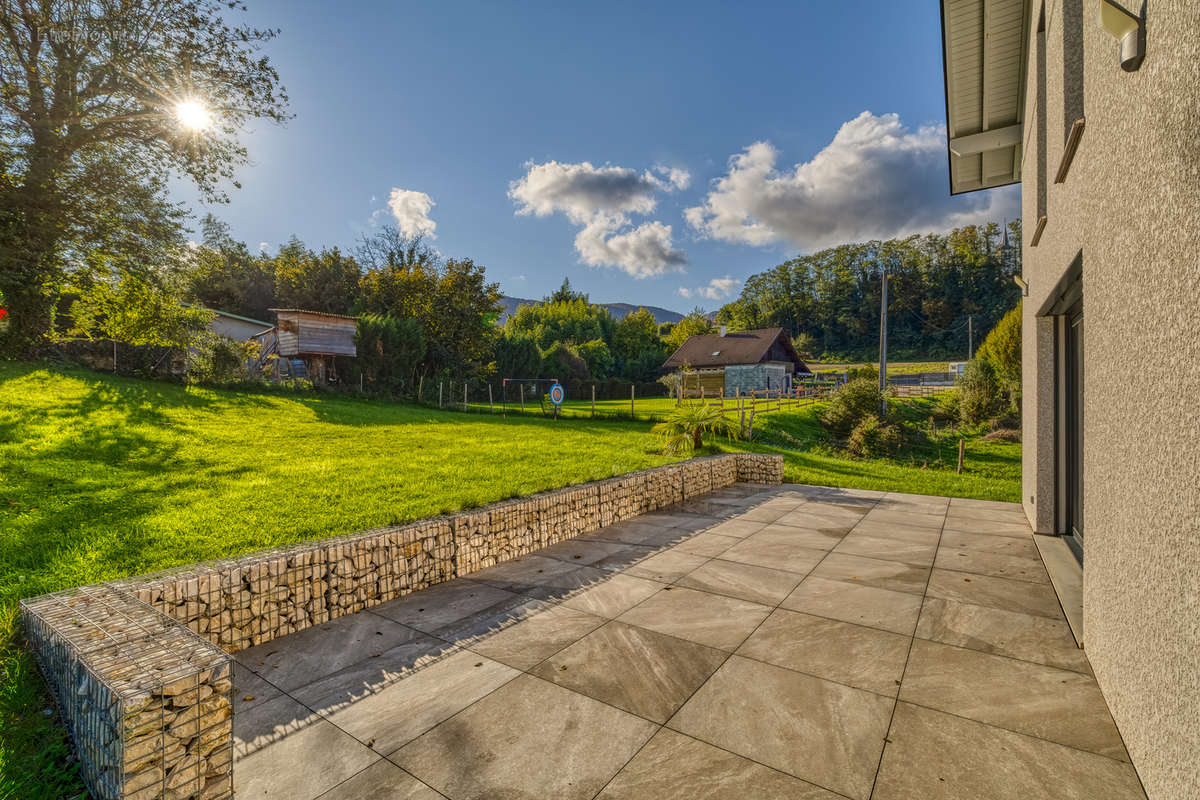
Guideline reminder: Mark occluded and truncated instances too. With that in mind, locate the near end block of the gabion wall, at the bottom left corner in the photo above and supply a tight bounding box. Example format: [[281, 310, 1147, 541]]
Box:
[[22, 584, 233, 800]]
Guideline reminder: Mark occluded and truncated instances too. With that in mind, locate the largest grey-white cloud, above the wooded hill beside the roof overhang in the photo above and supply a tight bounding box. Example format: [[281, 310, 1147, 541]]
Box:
[[684, 112, 1020, 249]]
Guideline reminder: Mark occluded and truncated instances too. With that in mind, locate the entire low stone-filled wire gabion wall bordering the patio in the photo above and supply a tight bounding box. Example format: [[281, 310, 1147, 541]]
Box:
[[22, 453, 784, 800]]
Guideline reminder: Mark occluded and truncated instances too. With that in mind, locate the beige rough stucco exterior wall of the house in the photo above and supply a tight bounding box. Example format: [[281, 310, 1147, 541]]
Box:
[[1022, 0, 1200, 800]]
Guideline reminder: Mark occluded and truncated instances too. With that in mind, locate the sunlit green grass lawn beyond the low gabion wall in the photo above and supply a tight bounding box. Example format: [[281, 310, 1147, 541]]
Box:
[[0, 362, 1020, 800]]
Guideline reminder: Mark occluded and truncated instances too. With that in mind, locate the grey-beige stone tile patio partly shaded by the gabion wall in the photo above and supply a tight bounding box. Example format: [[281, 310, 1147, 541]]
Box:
[[234, 485, 1145, 800]]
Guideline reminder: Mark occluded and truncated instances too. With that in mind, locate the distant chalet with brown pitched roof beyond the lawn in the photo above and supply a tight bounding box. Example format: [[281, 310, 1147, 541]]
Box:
[[662, 327, 811, 397]]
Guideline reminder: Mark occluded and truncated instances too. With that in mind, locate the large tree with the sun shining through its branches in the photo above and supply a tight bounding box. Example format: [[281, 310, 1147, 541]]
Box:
[[0, 0, 287, 353]]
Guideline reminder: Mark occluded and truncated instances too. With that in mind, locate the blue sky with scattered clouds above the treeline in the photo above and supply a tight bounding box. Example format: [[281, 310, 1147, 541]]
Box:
[[178, 0, 1019, 311]]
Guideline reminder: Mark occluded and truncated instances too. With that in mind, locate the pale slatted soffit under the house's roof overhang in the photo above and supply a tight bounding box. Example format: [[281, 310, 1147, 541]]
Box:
[[942, 0, 1030, 194]]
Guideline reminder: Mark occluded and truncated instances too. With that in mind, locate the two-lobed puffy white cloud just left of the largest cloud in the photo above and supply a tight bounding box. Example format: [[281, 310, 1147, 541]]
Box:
[[509, 161, 691, 278]]
